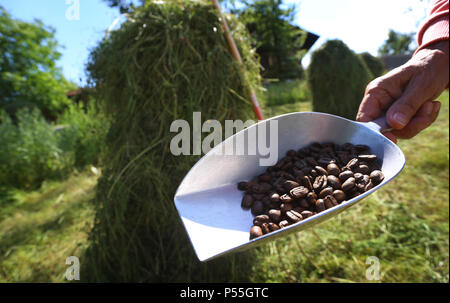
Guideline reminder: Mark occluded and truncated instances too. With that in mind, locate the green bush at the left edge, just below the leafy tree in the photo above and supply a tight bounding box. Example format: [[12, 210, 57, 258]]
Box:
[[0, 109, 70, 188]]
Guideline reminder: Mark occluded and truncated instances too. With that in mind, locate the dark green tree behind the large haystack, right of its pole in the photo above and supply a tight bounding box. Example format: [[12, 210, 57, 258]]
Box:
[[236, 0, 306, 79]]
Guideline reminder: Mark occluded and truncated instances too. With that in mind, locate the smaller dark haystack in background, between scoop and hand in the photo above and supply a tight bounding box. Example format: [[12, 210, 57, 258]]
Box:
[[308, 40, 373, 119]]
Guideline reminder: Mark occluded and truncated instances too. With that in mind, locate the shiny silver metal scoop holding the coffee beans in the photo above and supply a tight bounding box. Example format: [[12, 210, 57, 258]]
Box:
[[174, 112, 405, 261]]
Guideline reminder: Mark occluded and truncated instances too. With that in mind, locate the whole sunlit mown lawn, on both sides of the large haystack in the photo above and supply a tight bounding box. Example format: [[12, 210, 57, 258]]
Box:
[[0, 86, 449, 282]]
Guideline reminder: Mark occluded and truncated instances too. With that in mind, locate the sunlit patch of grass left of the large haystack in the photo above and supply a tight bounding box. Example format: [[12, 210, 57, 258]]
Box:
[[0, 172, 97, 282]]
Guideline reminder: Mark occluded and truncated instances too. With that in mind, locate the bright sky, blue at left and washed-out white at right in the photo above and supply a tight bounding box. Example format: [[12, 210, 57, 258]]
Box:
[[0, 0, 430, 84]]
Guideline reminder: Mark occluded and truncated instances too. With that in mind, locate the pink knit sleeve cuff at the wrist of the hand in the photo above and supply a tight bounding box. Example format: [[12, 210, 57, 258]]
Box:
[[416, 0, 449, 53]]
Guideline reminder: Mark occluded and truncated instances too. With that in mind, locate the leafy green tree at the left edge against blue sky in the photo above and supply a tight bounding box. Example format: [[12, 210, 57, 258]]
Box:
[[0, 6, 74, 119]]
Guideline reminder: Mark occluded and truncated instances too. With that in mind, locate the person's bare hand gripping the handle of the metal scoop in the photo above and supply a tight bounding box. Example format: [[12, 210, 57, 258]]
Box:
[[356, 40, 449, 143]]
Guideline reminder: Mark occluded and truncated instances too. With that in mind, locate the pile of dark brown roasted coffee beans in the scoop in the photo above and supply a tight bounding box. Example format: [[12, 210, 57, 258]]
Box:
[[237, 143, 384, 239]]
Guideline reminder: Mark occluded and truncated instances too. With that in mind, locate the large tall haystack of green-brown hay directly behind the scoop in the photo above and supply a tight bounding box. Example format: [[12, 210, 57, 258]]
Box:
[[81, 0, 260, 282]]
